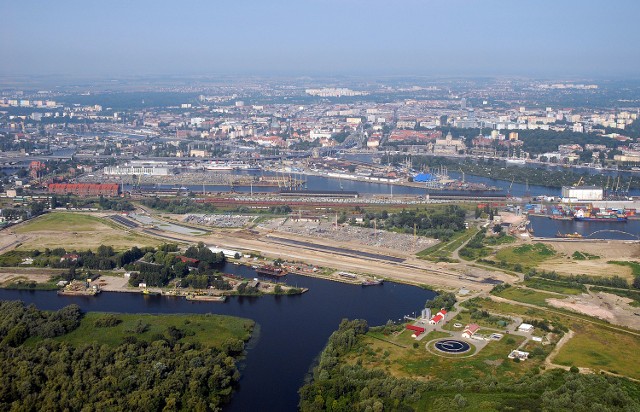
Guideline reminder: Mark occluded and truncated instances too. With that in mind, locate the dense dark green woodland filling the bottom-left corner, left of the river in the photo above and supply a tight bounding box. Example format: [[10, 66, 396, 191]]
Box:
[[0, 301, 243, 411]]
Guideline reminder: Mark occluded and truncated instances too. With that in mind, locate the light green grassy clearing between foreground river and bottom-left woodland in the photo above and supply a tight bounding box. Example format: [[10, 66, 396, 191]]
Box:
[[56, 312, 254, 347]]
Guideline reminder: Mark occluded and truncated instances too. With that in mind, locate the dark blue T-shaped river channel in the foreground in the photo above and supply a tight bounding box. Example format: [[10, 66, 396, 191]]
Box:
[[0, 264, 435, 412]]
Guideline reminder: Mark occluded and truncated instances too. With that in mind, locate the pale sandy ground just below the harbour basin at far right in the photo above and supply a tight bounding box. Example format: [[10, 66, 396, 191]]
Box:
[[538, 241, 640, 280]]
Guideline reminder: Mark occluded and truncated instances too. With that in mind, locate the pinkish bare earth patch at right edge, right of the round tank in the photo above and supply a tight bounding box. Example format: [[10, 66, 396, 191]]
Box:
[[547, 292, 640, 329]]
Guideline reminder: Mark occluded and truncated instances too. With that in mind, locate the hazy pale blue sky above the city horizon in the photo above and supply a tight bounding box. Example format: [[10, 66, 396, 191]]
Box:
[[0, 0, 640, 77]]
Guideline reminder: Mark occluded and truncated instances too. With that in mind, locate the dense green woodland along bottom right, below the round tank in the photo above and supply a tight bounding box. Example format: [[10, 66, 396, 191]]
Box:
[[300, 320, 640, 412]]
